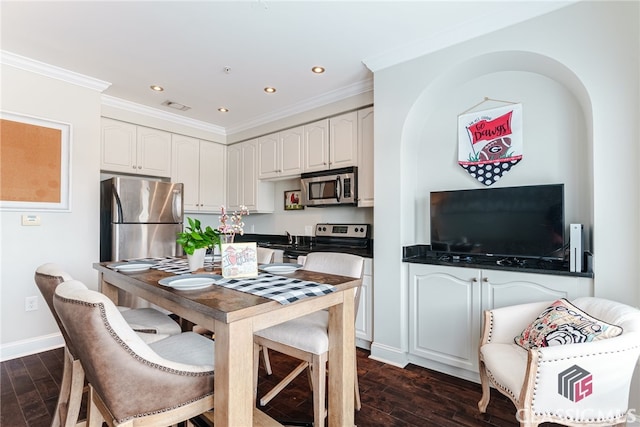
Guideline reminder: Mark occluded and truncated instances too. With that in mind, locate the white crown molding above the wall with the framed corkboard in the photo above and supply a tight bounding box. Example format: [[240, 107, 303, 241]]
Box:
[[0, 50, 111, 92]]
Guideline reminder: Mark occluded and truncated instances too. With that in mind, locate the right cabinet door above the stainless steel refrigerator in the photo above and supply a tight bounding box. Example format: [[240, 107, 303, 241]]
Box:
[[137, 126, 171, 177]]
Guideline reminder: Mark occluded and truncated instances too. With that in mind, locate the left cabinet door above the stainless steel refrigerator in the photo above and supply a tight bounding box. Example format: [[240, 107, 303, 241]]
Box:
[[100, 118, 137, 173]]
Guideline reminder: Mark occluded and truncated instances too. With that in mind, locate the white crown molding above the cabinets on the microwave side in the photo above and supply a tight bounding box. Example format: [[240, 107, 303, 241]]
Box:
[[227, 78, 373, 135]]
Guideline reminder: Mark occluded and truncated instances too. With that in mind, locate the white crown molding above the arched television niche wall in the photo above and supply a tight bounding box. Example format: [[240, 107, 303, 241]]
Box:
[[362, 0, 580, 73]]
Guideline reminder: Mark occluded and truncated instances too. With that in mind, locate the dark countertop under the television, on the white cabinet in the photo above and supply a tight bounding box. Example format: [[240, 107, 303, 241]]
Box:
[[402, 245, 593, 277]]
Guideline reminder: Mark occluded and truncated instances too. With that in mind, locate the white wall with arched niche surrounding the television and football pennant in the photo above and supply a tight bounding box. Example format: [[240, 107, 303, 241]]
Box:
[[372, 2, 640, 372]]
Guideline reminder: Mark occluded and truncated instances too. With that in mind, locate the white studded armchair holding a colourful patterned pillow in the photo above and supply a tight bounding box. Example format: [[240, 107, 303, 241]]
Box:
[[478, 297, 640, 427]]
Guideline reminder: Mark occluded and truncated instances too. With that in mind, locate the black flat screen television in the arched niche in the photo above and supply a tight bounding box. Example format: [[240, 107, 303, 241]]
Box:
[[430, 184, 564, 260]]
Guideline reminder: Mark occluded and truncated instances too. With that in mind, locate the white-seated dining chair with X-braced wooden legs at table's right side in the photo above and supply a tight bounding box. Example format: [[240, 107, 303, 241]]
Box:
[[254, 252, 364, 426]]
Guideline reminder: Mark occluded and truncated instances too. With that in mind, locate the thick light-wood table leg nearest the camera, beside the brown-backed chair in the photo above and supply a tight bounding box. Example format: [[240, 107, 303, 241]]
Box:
[[213, 319, 255, 427]]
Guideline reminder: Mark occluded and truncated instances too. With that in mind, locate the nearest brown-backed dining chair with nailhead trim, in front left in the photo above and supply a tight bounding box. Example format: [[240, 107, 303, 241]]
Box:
[[53, 280, 215, 427]]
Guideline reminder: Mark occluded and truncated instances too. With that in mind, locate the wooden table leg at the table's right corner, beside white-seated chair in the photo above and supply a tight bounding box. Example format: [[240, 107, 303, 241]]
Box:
[[328, 289, 356, 427]]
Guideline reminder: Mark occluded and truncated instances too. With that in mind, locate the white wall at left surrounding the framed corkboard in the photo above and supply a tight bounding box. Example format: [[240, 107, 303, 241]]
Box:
[[0, 65, 100, 360]]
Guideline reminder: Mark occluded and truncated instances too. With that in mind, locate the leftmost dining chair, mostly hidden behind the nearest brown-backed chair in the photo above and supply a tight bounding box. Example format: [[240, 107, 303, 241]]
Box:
[[34, 263, 182, 427]]
